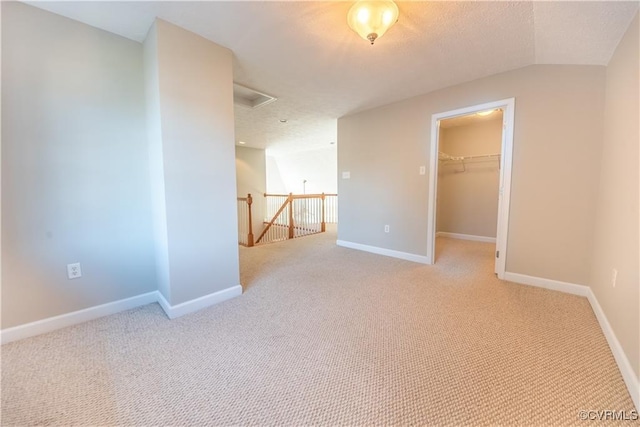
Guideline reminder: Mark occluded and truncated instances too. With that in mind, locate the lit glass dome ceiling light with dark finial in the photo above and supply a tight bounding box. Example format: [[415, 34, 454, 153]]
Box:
[[347, 0, 399, 44]]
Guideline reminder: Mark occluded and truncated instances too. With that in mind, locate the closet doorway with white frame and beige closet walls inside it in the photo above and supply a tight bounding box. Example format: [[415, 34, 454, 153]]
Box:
[[427, 98, 515, 279]]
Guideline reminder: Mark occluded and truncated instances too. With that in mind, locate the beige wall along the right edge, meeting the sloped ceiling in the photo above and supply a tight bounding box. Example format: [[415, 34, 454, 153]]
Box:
[[588, 15, 640, 378]]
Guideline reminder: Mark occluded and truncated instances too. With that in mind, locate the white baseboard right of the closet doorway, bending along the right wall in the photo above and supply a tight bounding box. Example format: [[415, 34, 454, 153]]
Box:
[[504, 272, 640, 410]]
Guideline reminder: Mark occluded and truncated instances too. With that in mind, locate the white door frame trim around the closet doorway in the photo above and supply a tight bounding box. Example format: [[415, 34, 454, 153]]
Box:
[[427, 98, 515, 279]]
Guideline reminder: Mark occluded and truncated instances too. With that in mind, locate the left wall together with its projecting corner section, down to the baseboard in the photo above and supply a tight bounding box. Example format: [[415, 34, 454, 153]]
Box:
[[2, 2, 239, 328]]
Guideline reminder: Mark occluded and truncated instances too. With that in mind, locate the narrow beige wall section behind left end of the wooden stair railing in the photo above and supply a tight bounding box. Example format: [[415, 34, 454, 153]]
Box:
[[236, 146, 267, 234]]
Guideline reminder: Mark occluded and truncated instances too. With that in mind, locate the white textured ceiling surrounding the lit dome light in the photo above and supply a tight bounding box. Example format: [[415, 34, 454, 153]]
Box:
[[27, 1, 638, 153]]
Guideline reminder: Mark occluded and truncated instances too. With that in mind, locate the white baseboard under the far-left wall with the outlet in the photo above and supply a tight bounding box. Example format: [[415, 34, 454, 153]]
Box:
[[0, 291, 158, 344]]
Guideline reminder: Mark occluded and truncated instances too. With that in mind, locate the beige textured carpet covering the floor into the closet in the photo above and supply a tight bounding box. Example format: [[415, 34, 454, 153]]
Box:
[[2, 227, 636, 426]]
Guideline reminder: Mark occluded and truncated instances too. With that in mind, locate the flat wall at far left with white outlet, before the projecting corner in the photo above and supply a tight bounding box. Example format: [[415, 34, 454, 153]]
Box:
[[2, 2, 156, 328]]
